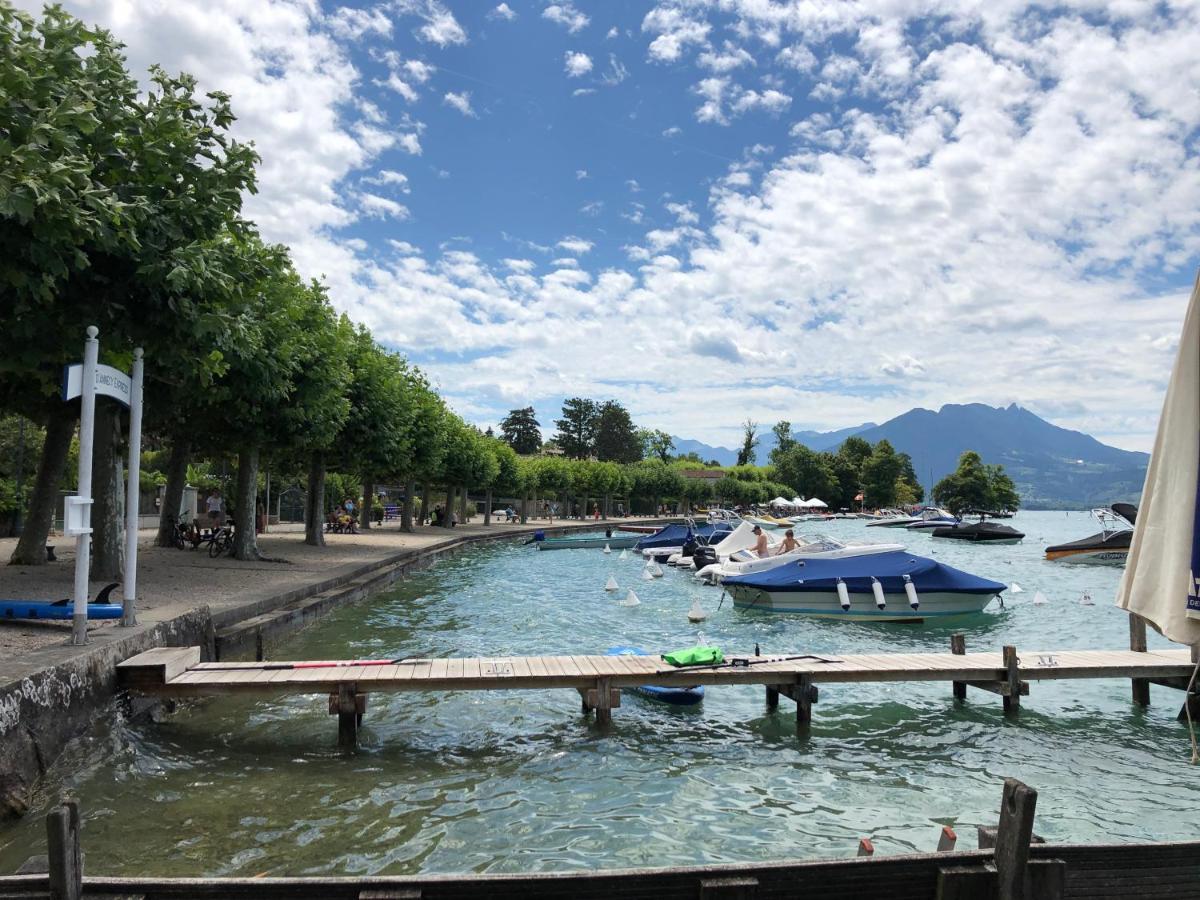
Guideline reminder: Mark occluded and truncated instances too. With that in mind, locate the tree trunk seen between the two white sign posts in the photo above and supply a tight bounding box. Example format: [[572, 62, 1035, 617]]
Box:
[[91, 400, 125, 581]]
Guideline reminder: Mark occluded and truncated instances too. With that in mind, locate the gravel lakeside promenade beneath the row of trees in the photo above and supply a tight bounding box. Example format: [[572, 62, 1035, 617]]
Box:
[[0, 517, 657, 685]]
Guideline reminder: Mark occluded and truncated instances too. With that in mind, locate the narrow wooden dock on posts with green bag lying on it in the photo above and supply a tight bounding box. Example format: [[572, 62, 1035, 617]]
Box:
[[118, 635, 1194, 748]]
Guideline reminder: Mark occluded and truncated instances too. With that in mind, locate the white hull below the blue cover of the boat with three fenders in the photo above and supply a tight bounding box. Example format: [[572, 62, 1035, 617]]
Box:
[[726, 584, 995, 622]]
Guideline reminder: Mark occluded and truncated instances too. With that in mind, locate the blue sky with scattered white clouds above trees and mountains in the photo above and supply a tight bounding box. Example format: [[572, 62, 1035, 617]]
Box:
[[22, 0, 1200, 449]]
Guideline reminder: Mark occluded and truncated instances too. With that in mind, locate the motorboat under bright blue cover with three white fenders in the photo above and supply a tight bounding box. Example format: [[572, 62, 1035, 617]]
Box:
[[722, 551, 1008, 622]]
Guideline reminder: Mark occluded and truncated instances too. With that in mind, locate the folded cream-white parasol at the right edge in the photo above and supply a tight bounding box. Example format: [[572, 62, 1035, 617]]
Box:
[[1117, 271, 1200, 644]]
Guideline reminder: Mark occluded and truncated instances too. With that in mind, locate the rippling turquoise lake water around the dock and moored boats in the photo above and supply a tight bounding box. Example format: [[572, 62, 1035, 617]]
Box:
[[0, 512, 1200, 876]]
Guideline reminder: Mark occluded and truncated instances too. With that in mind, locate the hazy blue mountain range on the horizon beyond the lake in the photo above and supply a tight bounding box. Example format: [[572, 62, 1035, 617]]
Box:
[[674, 403, 1150, 509]]
